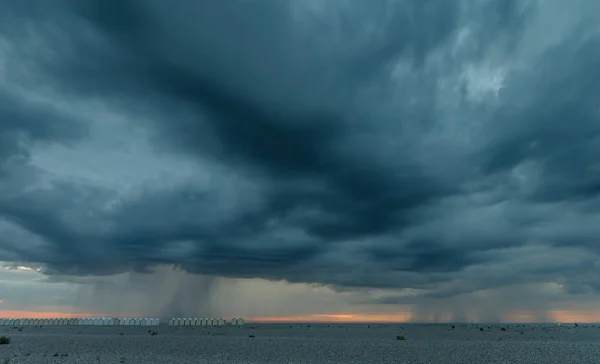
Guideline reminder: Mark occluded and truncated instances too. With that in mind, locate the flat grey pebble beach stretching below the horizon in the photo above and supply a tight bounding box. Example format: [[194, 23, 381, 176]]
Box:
[[0, 324, 600, 364]]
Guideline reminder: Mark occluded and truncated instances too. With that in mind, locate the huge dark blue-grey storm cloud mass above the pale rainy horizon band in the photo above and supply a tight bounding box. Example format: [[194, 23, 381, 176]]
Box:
[[0, 0, 600, 302]]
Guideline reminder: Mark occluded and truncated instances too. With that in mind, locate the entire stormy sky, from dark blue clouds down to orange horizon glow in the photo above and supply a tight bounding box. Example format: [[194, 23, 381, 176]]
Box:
[[0, 0, 600, 321]]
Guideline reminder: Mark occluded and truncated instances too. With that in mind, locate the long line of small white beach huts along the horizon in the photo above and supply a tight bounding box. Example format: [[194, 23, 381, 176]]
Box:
[[0, 317, 244, 327]]
